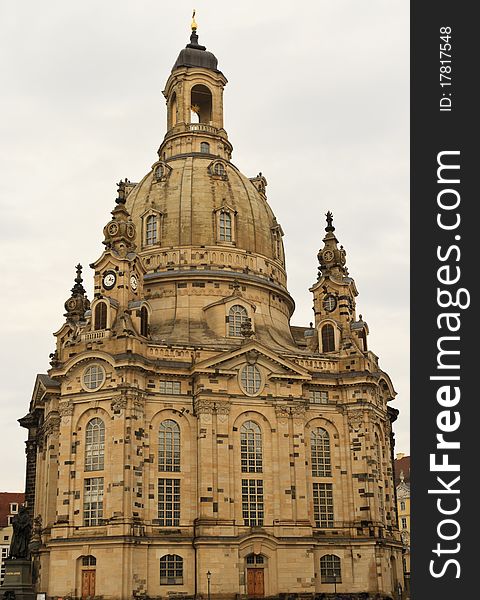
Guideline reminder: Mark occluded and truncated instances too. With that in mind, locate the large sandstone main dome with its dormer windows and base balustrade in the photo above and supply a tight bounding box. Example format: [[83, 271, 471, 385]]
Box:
[[126, 153, 286, 289]]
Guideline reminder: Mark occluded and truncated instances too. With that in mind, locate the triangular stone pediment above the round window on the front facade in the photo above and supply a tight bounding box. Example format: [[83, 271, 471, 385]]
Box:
[[192, 340, 311, 380]]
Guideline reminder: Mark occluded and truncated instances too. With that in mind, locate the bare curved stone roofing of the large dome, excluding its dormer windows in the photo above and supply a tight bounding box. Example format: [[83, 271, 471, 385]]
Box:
[[126, 153, 284, 260]]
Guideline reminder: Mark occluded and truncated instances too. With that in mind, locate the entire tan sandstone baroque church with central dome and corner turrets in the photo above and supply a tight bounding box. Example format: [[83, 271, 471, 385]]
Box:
[[19, 21, 403, 600]]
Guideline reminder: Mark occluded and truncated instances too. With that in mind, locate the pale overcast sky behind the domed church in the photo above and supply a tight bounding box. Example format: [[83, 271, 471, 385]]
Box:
[[0, 0, 409, 491]]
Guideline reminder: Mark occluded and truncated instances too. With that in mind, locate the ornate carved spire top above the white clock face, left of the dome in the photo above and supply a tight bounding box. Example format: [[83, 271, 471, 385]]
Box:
[[103, 178, 136, 256]]
